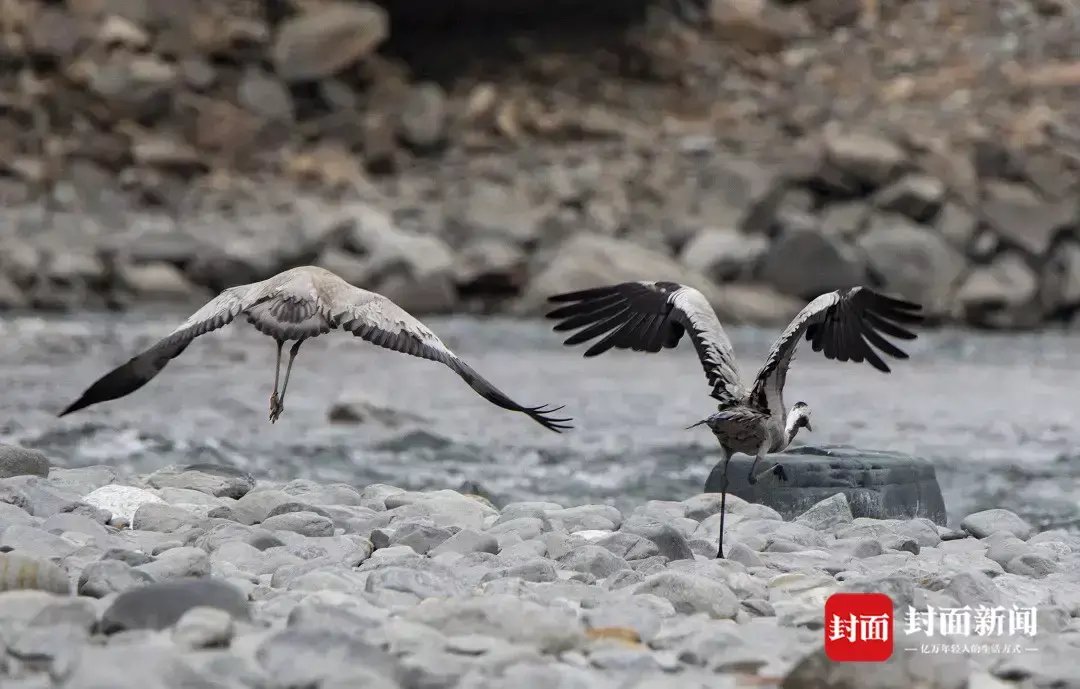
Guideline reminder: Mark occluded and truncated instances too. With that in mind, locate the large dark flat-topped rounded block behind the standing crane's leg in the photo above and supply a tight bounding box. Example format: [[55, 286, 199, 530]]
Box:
[[705, 445, 946, 525]]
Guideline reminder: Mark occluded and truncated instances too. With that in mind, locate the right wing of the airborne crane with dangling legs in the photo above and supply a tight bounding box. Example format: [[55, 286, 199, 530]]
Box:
[[330, 282, 573, 433]]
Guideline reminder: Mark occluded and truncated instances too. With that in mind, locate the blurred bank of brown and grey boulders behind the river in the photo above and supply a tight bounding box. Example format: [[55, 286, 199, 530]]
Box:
[[0, 0, 1080, 328]]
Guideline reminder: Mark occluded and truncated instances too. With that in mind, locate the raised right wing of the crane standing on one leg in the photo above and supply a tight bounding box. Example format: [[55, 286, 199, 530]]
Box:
[[751, 287, 922, 414]]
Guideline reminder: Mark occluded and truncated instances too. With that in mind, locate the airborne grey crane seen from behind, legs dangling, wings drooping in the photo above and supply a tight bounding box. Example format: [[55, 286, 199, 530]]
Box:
[[59, 266, 572, 433]]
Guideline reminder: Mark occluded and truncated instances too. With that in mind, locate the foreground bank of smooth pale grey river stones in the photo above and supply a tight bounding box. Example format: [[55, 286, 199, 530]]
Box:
[[0, 447, 1080, 689]]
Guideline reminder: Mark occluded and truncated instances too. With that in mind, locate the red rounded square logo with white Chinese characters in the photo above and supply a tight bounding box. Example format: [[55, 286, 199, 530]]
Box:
[[825, 593, 893, 663]]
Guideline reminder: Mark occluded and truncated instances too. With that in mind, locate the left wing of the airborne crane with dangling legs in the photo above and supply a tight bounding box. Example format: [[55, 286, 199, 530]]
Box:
[[58, 281, 270, 416]]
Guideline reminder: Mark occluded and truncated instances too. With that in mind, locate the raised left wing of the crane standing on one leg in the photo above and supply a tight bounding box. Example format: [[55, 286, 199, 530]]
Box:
[[548, 282, 742, 403]]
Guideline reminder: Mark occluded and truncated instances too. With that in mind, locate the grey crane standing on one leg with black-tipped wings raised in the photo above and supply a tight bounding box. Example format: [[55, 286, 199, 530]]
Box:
[[548, 282, 922, 558]]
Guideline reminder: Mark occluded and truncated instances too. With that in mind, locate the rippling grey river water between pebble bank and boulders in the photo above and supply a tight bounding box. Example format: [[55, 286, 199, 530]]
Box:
[[0, 314, 1080, 526]]
